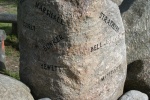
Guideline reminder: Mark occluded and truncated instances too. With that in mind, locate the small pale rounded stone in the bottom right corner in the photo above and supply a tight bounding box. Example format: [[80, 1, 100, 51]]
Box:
[[119, 90, 149, 100]]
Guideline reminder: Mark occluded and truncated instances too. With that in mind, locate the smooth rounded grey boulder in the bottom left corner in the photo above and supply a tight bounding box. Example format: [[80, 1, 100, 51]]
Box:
[[0, 74, 34, 100]]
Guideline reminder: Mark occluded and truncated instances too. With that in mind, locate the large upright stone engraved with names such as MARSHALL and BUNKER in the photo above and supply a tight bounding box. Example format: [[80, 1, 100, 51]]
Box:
[[18, 0, 126, 100]]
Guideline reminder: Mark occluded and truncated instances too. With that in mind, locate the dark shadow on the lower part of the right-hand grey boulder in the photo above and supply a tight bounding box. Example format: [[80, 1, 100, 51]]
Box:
[[124, 60, 149, 95]]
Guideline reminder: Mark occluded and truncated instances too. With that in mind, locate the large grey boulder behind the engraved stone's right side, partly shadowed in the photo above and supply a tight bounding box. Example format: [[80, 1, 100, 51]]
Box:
[[120, 0, 150, 96]]
